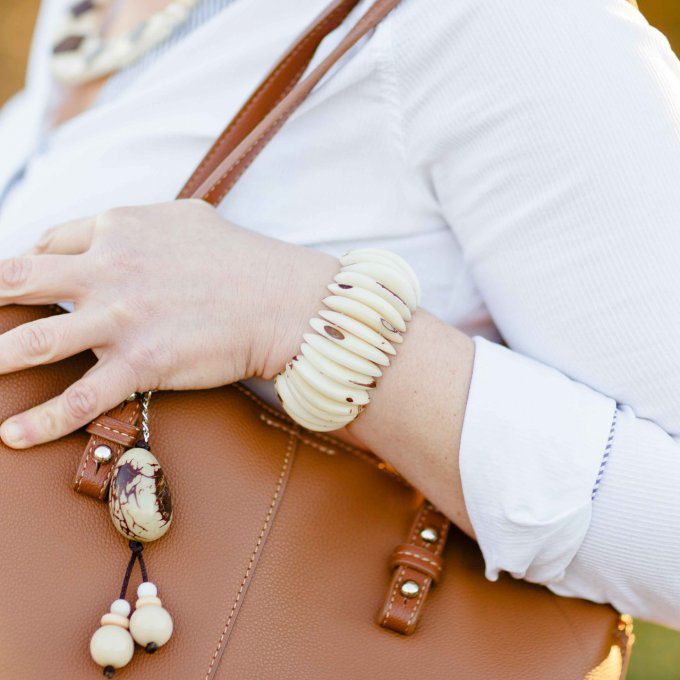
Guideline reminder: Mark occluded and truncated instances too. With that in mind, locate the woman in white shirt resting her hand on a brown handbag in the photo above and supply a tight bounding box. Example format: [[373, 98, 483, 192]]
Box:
[[0, 0, 680, 627]]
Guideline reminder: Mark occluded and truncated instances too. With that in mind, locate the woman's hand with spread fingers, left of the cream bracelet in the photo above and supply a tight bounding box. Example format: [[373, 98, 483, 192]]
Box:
[[0, 200, 337, 448]]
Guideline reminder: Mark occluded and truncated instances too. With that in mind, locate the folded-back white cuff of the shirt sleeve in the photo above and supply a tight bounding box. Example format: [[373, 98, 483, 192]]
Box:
[[460, 337, 616, 584]]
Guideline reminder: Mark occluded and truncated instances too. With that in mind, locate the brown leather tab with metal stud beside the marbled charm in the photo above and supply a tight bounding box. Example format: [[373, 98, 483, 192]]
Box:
[[73, 399, 141, 501]]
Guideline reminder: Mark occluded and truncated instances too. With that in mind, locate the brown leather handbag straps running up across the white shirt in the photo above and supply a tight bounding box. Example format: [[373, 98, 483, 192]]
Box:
[[178, 0, 399, 205]]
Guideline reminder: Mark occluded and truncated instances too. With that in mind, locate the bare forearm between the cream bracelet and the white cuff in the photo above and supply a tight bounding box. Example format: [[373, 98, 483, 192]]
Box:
[[348, 310, 474, 534]]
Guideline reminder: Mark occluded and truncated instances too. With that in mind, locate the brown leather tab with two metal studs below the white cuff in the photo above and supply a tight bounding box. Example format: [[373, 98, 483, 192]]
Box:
[[378, 501, 451, 635]]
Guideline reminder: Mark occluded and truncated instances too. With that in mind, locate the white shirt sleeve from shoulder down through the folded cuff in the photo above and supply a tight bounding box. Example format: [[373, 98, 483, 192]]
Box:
[[393, 0, 680, 627]]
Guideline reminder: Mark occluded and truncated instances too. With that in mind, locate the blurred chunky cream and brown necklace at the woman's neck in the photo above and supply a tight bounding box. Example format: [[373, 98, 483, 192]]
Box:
[[52, 0, 198, 85]]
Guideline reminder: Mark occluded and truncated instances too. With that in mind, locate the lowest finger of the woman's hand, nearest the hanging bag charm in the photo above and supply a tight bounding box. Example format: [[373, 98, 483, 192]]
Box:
[[0, 361, 137, 449]]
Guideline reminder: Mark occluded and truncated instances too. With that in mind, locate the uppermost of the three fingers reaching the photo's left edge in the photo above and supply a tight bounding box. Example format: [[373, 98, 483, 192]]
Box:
[[0, 255, 87, 305]]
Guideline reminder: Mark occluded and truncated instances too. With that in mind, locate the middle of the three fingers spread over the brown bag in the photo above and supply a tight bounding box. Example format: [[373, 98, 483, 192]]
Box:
[[0, 312, 108, 375]]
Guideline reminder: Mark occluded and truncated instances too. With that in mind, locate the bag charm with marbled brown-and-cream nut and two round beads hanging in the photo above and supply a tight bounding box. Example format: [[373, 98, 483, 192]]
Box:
[[90, 392, 173, 678]]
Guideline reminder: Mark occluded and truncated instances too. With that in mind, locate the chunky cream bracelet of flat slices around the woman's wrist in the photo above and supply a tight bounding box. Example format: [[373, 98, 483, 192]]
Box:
[[274, 248, 420, 432]]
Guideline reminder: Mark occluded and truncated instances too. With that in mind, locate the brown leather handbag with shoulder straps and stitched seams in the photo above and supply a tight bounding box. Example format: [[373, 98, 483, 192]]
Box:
[[0, 0, 632, 680]]
